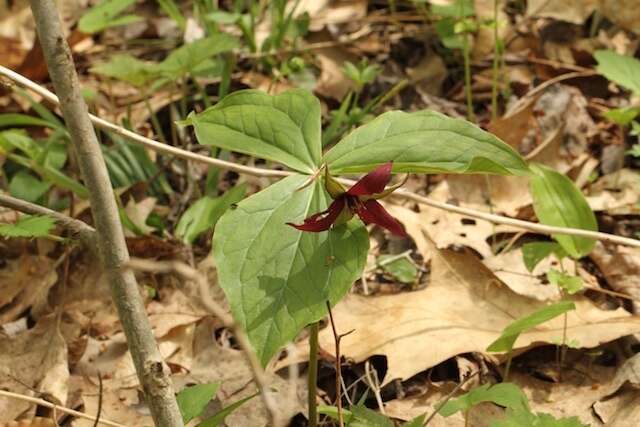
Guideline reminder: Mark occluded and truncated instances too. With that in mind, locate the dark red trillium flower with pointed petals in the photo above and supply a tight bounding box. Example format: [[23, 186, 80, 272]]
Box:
[[287, 162, 407, 237]]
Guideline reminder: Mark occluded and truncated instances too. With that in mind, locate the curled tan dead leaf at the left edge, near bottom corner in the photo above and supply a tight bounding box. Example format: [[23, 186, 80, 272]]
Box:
[[0, 315, 69, 422]]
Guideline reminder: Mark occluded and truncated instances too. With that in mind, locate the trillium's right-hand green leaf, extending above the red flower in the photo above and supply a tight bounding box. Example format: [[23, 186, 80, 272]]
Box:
[[324, 111, 529, 175]]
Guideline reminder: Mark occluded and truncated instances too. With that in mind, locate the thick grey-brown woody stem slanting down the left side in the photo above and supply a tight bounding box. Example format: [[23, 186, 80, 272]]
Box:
[[31, 0, 184, 427]]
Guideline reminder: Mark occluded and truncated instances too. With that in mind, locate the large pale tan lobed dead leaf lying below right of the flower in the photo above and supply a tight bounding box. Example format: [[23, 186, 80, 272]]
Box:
[[277, 249, 640, 384]]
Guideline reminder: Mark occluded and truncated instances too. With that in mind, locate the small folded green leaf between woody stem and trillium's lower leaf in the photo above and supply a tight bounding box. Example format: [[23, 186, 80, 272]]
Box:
[[176, 184, 247, 244]]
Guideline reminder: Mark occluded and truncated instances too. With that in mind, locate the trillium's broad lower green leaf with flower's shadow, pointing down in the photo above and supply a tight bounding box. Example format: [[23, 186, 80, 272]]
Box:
[[213, 175, 369, 365]]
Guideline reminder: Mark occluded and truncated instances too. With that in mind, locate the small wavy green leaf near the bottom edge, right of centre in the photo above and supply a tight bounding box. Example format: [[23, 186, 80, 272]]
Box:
[[438, 383, 528, 417]]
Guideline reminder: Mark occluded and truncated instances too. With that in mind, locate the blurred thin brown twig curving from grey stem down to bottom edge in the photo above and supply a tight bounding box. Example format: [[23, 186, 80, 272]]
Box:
[[124, 258, 283, 427]]
